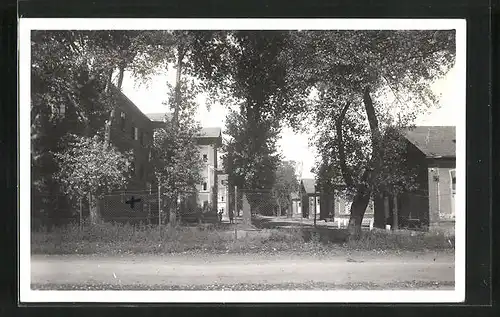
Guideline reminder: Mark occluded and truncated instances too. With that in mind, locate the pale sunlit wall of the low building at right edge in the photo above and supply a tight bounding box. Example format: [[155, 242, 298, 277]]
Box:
[[428, 159, 455, 226]]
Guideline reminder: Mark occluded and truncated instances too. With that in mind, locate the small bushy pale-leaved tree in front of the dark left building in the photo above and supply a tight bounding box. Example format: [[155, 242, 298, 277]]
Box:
[[54, 135, 131, 224]]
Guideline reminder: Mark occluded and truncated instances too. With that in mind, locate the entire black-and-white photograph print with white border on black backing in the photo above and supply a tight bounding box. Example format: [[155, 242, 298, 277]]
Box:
[[19, 18, 466, 303]]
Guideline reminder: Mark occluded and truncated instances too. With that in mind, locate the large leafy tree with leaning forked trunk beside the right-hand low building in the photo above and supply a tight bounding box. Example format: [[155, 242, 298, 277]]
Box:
[[284, 31, 455, 235]]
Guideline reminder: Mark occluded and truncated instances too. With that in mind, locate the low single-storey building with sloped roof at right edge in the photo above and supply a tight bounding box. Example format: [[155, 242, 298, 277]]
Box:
[[375, 126, 456, 227]]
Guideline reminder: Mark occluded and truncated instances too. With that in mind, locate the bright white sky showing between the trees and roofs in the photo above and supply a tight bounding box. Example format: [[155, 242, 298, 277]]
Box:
[[122, 68, 459, 178]]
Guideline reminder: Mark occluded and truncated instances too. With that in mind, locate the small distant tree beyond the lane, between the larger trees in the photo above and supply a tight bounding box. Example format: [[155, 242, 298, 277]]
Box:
[[273, 161, 299, 215]]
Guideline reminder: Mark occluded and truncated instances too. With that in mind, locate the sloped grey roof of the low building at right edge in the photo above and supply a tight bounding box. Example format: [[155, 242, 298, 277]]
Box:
[[406, 126, 456, 158]]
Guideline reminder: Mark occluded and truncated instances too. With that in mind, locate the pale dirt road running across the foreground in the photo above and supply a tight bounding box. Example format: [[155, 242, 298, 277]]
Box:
[[31, 253, 454, 286]]
